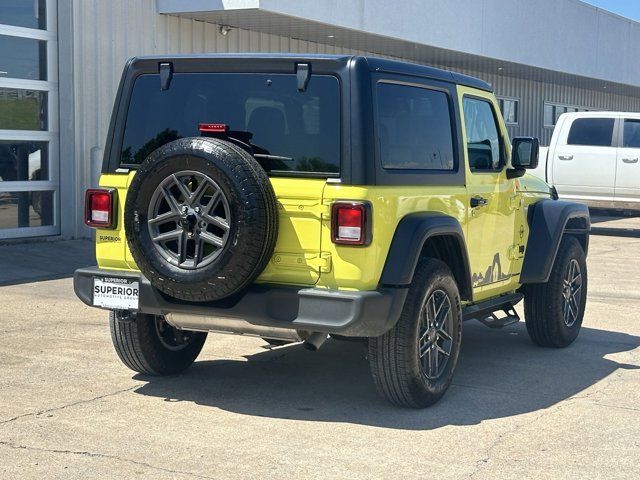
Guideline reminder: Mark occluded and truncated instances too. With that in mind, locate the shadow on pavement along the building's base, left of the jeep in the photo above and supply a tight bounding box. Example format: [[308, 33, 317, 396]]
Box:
[[0, 240, 96, 286]]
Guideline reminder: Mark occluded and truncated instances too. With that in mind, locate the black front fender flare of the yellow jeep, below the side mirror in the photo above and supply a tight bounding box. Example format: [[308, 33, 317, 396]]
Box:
[[520, 200, 591, 284]]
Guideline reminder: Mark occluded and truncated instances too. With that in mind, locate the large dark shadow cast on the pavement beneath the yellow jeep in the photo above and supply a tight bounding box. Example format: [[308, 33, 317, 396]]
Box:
[[136, 323, 640, 430]]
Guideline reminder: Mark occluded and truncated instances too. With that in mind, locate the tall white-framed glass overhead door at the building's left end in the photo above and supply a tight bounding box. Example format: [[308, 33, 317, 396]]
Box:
[[0, 0, 60, 240]]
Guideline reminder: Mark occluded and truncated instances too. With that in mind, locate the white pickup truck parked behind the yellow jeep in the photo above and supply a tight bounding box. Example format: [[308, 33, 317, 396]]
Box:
[[530, 112, 640, 210]]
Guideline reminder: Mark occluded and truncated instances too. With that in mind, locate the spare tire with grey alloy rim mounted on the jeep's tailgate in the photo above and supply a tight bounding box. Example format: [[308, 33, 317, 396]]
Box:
[[124, 138, 278, 302]]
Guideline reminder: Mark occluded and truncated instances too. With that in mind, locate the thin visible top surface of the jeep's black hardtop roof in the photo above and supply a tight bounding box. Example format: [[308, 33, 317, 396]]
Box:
[[133, 53, 493, 92]]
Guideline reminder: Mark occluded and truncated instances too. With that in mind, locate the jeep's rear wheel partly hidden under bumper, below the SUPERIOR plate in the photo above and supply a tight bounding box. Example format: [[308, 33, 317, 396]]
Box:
[[109, 312, 207, 376]]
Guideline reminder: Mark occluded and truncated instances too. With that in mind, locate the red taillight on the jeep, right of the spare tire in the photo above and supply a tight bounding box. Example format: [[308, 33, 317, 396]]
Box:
[[331, 202, 371, 245]]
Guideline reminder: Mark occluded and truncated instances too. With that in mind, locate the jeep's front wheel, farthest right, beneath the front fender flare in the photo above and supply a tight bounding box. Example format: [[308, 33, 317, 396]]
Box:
[[524, 236, 587, 348]]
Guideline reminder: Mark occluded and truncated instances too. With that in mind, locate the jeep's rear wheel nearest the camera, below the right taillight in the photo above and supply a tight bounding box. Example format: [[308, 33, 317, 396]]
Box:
[[369, 258, 462, 408]]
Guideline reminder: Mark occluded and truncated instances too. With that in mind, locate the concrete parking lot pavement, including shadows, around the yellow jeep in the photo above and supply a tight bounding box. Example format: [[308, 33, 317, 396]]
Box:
[[0, 218, 640, 479]]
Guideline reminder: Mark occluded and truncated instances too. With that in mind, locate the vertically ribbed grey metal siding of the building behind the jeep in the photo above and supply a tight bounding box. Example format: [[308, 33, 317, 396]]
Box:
[[70, 0, 640, 236]]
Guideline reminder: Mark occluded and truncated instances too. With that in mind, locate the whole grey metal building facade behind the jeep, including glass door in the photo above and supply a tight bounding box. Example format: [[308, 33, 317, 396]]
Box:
[[0, 0, 640, 241]]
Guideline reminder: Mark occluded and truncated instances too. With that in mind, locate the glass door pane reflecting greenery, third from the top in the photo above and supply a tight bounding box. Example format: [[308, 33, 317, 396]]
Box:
[[0, 88, 47, 130]]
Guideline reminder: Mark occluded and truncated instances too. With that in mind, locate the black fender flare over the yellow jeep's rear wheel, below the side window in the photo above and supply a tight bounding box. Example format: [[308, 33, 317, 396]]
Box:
[[380, 212, 473, 300]]
